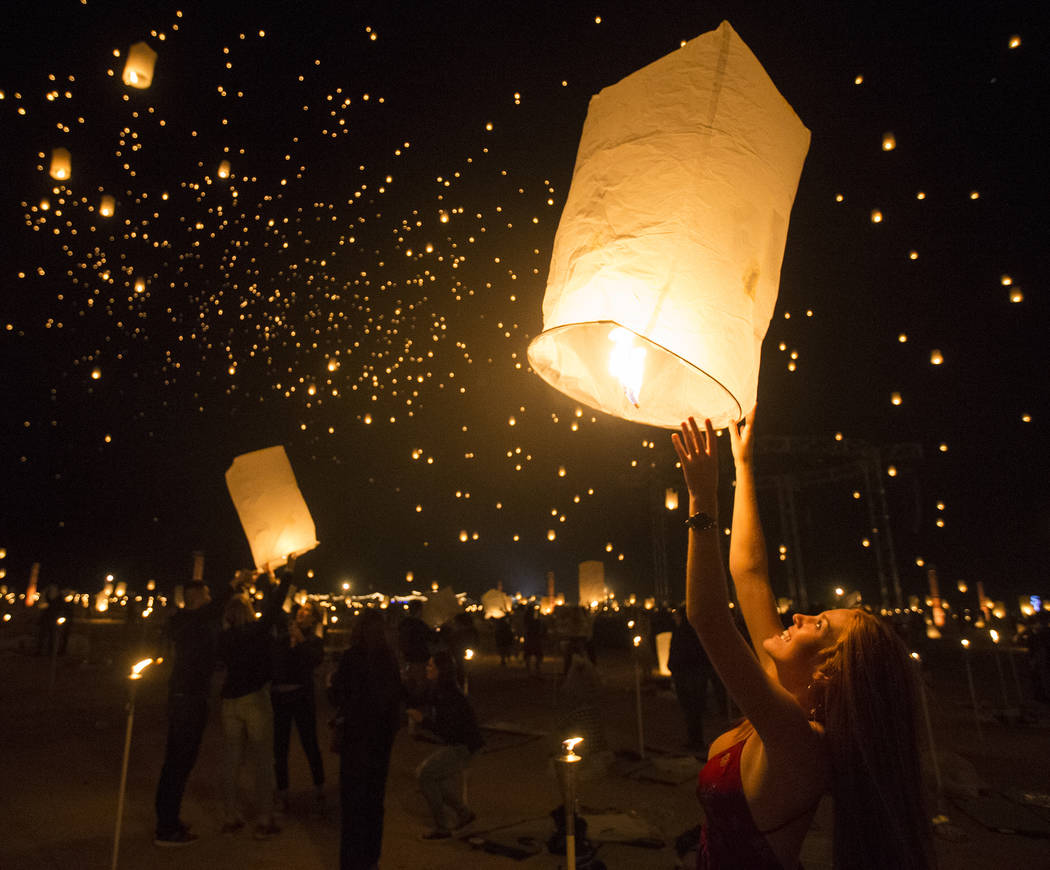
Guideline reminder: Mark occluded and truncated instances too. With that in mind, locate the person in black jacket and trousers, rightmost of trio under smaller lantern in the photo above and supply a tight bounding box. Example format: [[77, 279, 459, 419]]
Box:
[[270, 600, 324, 812]]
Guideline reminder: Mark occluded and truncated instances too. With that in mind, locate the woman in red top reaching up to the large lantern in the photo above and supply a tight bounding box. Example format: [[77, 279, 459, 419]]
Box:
[[672, 413, 935, 870]]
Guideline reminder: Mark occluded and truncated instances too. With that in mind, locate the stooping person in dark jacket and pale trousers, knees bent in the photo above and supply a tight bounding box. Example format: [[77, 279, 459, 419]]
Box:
[[408, 652, 484, 840]]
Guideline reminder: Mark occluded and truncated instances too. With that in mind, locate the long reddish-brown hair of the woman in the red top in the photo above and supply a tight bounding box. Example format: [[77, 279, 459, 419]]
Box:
[[818, 610, 937, 870]]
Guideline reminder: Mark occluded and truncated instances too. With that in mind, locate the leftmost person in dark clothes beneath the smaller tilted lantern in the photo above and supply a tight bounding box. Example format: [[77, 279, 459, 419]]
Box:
[[153, 577, 238, 846]]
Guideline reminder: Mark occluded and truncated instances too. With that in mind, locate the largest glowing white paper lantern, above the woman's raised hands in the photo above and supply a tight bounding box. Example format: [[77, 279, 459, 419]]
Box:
[[528, 21, 810, 428]]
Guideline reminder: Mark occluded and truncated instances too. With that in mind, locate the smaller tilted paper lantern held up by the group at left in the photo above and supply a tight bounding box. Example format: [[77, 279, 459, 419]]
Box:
[[226, 445, 318, 570]]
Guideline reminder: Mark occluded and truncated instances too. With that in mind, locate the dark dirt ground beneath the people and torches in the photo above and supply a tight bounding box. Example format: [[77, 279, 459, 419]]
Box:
[[0, 619, 1050, 870]]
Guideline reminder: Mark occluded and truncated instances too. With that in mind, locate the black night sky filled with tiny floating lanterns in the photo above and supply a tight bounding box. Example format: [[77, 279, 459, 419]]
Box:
[[0, 0, 1050, 601]]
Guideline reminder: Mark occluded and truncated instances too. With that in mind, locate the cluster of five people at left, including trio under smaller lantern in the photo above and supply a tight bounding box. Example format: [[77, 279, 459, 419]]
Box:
[[154, 557, 483, 870]]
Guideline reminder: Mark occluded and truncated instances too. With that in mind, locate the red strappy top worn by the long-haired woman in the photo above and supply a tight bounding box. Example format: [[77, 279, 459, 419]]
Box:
[[696, 738, 810, 870]]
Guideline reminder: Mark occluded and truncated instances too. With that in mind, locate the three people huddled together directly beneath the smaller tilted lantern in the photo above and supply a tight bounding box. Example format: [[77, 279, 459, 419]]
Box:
[[154, 558, 324, 846]]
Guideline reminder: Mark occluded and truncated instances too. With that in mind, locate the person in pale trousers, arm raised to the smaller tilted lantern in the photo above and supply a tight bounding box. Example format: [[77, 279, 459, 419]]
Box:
[[218, 559, 294, 840]]
